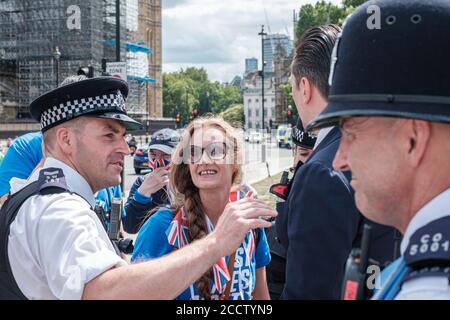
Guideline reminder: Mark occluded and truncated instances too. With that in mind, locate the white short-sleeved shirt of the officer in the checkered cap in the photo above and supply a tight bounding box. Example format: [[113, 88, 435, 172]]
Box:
[[8, 158, 126, 299]]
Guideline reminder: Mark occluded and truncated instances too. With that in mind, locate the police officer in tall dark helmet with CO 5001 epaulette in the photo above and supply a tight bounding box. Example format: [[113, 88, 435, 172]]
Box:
[[309, 0, 450, 299]]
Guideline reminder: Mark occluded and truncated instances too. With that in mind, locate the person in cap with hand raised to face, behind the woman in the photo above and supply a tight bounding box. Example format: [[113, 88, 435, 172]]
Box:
[[122, 128, 180, 234]]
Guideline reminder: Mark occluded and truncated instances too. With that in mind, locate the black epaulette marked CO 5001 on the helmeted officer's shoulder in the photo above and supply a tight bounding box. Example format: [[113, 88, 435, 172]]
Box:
[[404, 216, 450, 281]]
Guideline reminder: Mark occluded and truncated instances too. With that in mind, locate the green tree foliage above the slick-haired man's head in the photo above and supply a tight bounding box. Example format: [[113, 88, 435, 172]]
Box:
[[295, 0, 367, 41]]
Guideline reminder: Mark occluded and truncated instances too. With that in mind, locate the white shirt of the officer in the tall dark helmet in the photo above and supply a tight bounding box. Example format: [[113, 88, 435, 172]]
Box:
[[396, 189, 450, 300]]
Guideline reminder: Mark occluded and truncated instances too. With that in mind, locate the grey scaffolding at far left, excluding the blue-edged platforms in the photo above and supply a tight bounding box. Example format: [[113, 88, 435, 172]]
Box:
[[0, 0, 104, 118]]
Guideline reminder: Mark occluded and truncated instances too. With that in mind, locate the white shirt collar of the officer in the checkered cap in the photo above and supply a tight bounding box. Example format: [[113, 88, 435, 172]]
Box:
[[28, 157, 95, 208]]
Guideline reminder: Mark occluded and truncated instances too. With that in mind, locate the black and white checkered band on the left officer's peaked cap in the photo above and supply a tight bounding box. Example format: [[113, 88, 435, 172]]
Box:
[[41, 90, 125, 130]]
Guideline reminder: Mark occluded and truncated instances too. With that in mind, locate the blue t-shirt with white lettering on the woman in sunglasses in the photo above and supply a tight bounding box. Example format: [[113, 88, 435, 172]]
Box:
[[131, 208, 271, 300]]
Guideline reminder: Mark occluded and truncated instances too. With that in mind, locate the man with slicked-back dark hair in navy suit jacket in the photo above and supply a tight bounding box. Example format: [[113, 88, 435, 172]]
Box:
[[279, 25, 394, 299]]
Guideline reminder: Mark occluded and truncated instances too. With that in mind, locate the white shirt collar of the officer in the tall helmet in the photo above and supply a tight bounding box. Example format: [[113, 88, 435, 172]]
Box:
[[400, 188, 450, 255]]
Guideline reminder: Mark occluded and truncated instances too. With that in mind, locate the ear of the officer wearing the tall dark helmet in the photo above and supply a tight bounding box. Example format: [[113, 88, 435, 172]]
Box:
[[406, 119, 431, 167]]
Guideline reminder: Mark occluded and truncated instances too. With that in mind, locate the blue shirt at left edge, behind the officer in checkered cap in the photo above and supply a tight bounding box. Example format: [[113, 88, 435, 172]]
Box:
[[0, 131, 42, 196]]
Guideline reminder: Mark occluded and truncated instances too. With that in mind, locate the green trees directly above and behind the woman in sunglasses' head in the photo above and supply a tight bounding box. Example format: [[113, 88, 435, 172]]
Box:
[[163, 68, 242, 124]]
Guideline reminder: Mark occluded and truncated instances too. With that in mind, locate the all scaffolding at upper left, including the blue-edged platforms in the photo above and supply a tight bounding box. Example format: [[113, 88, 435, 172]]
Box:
[[0, 0, 160, 118]]
